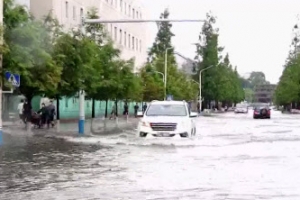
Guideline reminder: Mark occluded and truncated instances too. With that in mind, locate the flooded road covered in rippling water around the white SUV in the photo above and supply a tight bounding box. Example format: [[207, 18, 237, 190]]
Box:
[[0, 111, 300, 200]]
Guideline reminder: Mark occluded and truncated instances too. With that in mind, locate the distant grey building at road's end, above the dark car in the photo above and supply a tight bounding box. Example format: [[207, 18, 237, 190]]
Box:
[[254, 84, 276, 103]]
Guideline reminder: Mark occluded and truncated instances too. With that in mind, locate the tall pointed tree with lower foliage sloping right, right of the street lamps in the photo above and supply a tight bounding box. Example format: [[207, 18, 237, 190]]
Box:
[[194, 13, 244, 107]]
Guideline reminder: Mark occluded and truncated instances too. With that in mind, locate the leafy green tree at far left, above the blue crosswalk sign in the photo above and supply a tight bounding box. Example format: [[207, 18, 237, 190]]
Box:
[[3, 0, 62, 101]]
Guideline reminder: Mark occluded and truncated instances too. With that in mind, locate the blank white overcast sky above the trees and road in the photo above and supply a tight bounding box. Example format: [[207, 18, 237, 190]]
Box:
[[142, 0, 300, 83]]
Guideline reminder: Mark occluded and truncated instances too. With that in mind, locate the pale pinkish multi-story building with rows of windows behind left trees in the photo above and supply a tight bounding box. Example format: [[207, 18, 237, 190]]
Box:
[[29, 0, 148, 71]]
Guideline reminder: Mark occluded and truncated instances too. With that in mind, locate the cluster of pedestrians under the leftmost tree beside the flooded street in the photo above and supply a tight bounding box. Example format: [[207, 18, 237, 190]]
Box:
[[18, 99, 56, 128]]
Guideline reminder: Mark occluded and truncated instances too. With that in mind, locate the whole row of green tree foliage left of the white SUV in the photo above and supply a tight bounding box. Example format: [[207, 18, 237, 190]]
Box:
[[2, 0, 143, 104]]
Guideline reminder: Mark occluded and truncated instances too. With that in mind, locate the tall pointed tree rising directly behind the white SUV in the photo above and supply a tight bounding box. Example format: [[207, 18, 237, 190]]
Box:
[[141, 9, 198, 100]]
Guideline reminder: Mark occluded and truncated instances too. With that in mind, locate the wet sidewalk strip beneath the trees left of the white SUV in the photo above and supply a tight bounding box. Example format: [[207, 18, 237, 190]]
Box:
[[3, 117, 140, 137]]
